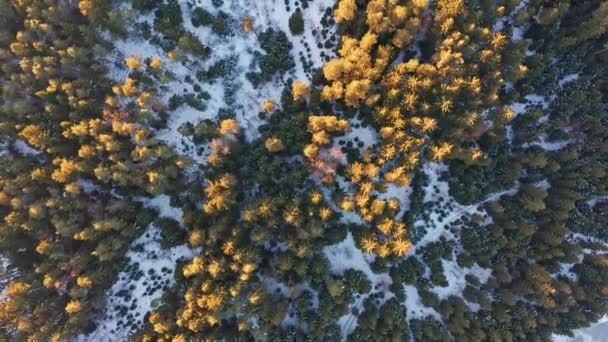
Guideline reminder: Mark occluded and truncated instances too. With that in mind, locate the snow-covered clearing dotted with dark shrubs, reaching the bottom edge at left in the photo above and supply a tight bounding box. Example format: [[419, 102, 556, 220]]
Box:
[[77, 225, 200, 342]]
